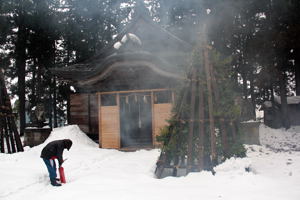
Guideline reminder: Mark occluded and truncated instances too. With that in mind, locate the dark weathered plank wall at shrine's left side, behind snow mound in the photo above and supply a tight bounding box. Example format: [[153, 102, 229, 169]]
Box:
[[69, 94, 99, 136]]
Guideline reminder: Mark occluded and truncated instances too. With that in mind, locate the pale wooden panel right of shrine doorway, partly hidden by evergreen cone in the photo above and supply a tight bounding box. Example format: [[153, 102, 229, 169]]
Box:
[[152, 103, 172, 146]]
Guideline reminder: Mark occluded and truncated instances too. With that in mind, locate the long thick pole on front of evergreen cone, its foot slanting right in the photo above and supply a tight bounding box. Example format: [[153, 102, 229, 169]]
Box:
[[203, 47, 217, 165]]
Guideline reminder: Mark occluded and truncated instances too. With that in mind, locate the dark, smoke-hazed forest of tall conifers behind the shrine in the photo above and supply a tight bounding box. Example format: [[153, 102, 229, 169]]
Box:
[[0, 0, 300, 135]]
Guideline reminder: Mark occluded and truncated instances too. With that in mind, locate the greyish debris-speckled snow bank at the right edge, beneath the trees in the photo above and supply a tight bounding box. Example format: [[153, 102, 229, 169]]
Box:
[[259, 124, 300, 151]]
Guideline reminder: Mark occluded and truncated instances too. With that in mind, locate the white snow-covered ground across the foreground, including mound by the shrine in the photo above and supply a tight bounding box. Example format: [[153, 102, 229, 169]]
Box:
[[0, 126, 300, 200]]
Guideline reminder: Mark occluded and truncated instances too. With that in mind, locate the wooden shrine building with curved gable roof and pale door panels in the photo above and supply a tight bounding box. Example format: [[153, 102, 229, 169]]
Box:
[[52, 5, 191, 149]]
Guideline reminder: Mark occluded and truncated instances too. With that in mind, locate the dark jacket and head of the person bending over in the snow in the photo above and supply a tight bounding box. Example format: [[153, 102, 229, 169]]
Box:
[[41, 139, 72, 165]]
